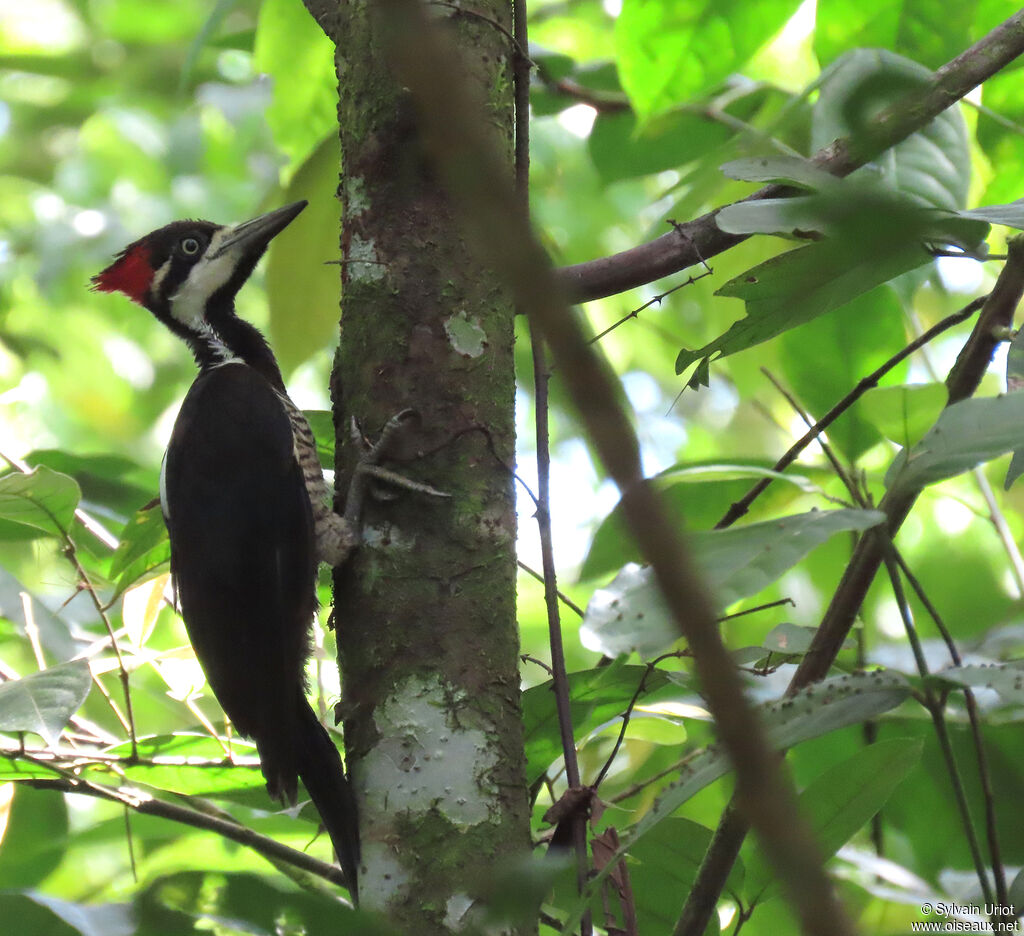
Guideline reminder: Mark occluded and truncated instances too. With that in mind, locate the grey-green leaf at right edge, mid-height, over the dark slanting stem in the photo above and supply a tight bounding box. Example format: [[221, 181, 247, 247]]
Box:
[[886, 393, 1024, 491]]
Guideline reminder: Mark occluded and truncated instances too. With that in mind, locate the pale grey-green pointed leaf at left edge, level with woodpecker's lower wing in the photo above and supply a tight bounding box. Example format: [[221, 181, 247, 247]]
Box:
[[0, 660, 92, 746]]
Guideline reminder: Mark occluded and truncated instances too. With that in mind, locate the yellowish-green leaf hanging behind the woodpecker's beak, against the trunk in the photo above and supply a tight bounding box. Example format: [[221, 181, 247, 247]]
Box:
[[266, 134, 341, 373]]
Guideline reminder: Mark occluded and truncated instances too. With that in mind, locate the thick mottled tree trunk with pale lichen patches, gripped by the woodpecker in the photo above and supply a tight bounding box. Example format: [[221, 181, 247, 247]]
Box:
[[306, 0, 528, 934]]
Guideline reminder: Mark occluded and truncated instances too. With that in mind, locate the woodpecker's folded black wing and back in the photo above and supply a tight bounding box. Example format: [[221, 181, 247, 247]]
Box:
[[163, 364, 316, 799]]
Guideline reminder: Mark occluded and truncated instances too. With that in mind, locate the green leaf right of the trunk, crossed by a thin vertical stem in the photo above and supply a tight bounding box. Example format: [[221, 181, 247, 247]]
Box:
[[522, 662, 681, 783]]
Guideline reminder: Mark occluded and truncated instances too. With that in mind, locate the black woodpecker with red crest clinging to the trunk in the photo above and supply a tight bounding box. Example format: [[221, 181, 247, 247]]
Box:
[[93, 202, 359, 899]]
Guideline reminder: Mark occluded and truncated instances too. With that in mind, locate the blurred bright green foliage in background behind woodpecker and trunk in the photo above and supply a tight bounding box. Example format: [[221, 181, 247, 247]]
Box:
[[0, 0, 1024, 936]]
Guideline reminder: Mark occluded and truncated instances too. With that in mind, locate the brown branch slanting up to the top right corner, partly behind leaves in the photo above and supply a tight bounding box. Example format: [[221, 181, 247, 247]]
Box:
[[556, 9, 1024, 302]]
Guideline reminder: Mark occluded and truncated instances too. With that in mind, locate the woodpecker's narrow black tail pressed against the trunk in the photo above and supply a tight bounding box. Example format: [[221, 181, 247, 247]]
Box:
[[296, 699, 359, 903]]
